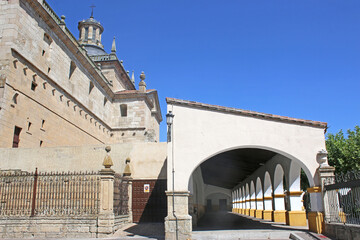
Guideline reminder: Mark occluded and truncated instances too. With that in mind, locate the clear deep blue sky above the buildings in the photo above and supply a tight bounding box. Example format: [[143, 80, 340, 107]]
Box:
[[48, 0, 360, 141]]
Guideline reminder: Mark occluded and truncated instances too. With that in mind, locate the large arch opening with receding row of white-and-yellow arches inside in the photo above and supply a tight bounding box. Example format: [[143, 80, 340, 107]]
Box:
[[188, 148, 311, 229]]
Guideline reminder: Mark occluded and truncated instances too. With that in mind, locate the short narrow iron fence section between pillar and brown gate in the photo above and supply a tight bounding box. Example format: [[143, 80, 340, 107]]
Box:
[[113, 174, 129, 216]]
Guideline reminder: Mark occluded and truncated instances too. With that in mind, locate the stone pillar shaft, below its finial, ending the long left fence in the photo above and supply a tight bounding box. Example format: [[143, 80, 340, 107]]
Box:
[[98, 168, 115, 237]]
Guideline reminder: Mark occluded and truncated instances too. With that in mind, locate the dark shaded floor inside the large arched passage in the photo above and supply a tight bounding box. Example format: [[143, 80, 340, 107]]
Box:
[[193, 211, 307, 231]]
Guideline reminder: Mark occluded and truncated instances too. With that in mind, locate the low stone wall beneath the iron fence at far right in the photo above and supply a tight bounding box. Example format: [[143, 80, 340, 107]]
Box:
[[325, 223, 360, 240]]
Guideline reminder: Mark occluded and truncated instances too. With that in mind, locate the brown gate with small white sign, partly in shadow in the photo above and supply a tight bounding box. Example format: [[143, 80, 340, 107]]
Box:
[[132, 179, 167, 222]]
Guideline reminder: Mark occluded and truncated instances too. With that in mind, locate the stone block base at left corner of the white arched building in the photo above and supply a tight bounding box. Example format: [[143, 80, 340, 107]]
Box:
[[165, 191, 192, 240]]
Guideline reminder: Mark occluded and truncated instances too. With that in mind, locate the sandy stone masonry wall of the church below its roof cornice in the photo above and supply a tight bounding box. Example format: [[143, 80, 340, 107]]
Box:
[[0, 0, 158, 148]]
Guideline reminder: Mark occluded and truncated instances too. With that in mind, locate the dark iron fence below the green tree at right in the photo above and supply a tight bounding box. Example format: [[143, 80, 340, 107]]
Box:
[[324, 171, 360, 224]]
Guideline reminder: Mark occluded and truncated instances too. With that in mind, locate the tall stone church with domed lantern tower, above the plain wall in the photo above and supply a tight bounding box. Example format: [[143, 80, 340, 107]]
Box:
[[0, 1, 162, 148]]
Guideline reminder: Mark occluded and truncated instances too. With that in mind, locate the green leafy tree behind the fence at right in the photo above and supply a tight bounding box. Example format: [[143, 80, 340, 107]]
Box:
[[326, 126, 360, 172]]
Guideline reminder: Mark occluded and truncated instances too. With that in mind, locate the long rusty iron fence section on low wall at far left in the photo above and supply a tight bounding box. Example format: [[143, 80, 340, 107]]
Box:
[[0, 171, 100, 216]]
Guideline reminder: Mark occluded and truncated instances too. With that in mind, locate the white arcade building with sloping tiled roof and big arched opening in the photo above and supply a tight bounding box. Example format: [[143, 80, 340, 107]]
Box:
[[165, 98, 333, 239]]
